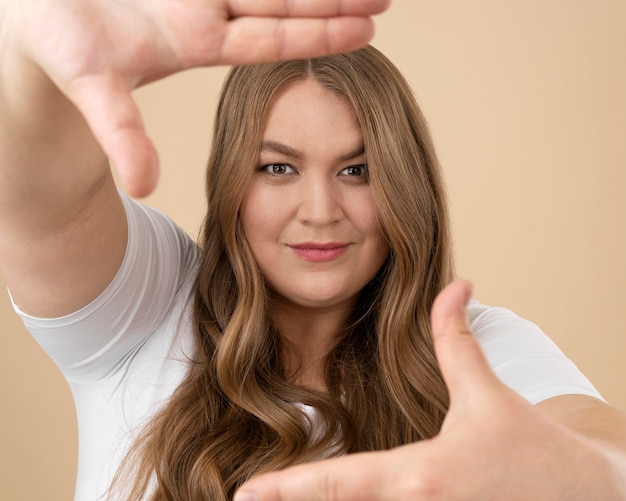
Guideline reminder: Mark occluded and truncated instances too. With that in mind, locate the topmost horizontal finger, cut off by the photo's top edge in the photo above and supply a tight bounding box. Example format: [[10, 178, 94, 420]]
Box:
[[227, 0, 390, 17]]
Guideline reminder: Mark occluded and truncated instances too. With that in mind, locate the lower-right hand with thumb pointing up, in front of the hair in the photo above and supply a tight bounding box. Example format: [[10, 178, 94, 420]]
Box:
[[235, 282, 622, 501]]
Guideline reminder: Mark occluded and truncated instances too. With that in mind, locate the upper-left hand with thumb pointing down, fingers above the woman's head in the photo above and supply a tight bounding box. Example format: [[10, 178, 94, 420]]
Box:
[[0, 0, 389, 196]]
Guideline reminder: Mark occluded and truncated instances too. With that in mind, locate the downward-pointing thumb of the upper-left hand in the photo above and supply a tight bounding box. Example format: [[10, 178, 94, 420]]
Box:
[[66, 75, 159, 197]]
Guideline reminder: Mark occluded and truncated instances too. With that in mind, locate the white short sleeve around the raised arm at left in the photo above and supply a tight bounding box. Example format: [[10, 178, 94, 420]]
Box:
[[13, 193, 199, 382]]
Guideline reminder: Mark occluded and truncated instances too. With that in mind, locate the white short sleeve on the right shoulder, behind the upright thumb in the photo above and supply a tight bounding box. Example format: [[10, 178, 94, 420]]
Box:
[[468, 301, 602, 404]]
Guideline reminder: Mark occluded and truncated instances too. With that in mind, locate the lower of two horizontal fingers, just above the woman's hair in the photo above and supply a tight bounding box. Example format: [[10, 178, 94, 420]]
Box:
[[220, 17, 374, 64]]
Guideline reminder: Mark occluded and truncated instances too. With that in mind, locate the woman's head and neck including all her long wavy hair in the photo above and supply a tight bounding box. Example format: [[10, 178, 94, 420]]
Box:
[[114, 48, 452, 499]]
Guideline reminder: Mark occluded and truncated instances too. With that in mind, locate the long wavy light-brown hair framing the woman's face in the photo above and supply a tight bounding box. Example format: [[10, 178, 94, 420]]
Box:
[[114, 46, 453, 501]]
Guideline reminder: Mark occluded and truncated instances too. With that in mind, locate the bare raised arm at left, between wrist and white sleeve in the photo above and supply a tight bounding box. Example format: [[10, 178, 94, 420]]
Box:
[[0, 0, 126, 316]]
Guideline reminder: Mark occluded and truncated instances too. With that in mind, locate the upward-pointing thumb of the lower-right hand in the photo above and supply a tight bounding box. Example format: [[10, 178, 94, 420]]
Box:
[[431, 280, 496, 409]]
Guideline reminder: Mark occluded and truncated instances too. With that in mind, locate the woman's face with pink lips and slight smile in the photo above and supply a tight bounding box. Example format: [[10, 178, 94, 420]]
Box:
[[241, 80, 389, 308]]
